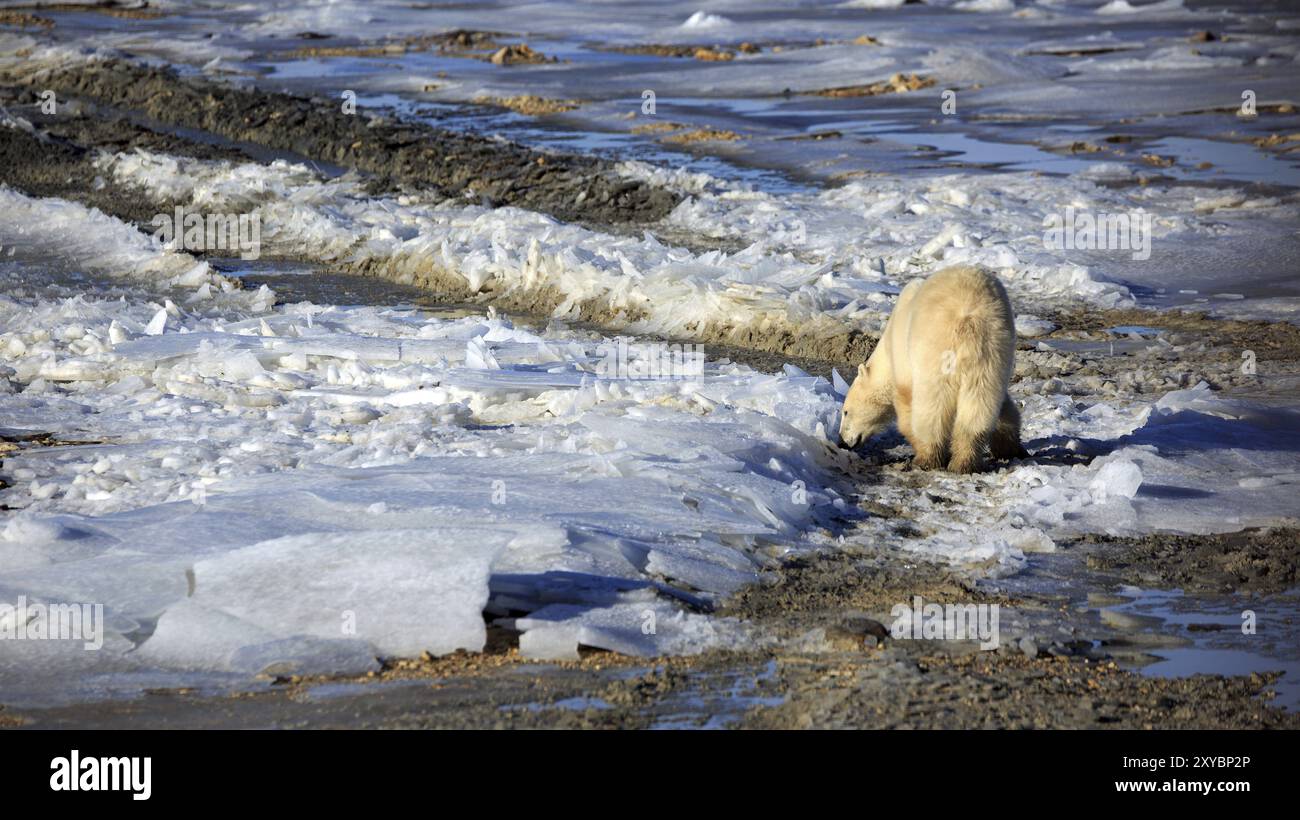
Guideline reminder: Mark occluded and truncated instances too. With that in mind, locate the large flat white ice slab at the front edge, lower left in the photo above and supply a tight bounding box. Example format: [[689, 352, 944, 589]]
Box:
[[146, 528, 514, 668]]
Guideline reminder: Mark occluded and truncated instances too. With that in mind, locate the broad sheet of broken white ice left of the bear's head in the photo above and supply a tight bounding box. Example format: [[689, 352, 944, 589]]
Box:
[[0, 189, 853, 700]]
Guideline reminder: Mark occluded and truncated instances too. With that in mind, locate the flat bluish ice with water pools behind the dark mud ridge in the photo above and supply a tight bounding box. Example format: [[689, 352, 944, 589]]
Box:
[[17, 0, 1300, 185]]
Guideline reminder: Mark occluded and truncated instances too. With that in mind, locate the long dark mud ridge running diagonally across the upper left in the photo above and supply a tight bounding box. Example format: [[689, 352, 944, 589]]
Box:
[[3, 53, 679, 225]]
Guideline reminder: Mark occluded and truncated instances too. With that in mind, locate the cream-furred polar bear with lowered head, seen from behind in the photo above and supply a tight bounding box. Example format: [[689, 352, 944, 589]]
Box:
[[840, 266, 1028, 473]]
